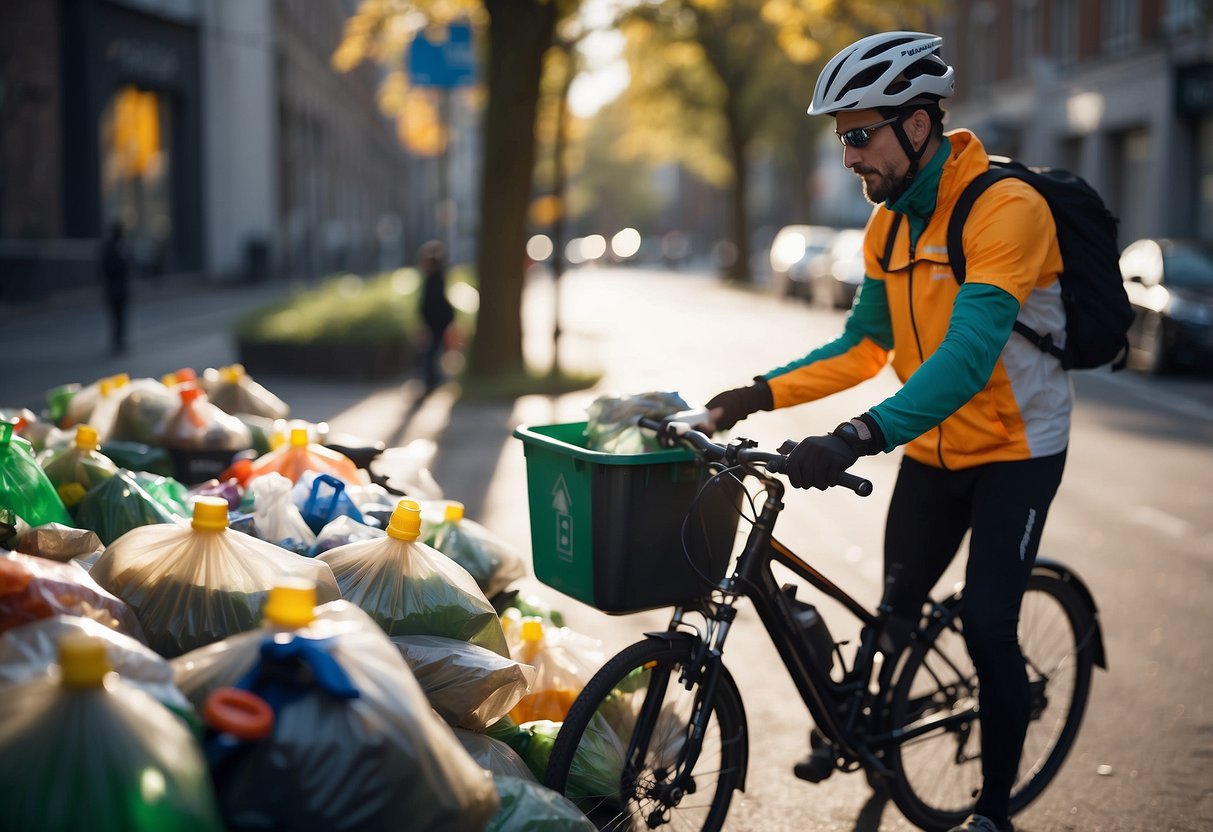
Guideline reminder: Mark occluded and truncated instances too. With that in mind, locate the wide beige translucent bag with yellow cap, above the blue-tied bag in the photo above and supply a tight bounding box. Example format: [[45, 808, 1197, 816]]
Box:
[[90, 497, 341, 657]]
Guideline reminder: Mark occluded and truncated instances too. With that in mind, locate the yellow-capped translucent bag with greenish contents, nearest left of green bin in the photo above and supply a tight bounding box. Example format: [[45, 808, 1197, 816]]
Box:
[[317, 500, 509, 657]]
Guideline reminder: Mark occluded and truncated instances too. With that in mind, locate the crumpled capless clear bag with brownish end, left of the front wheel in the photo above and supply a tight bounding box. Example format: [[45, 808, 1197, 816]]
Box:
[[392, 636, 535, 731]]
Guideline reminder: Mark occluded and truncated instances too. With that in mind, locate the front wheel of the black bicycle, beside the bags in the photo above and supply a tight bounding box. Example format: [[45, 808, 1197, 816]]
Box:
[[545, 637, 747, 832]]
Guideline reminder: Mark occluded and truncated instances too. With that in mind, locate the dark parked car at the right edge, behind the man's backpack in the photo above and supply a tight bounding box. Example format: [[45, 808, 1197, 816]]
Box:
[[1121, 238, 1213, 372]]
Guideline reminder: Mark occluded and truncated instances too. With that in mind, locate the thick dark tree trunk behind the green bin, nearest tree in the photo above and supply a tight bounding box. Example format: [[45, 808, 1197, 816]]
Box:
[[467, 0, 556, 378]]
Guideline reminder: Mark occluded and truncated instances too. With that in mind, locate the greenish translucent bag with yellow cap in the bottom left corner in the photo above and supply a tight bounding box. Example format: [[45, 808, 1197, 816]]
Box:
[[0, 634, 223, 832]]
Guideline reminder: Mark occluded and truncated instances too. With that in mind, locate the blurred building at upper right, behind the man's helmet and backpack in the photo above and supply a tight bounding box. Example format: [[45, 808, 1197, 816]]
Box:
[[935, 0, 1213, 245]]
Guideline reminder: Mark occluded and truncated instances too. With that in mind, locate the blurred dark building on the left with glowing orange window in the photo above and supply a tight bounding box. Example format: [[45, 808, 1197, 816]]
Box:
[[0, 0, 446, 300]]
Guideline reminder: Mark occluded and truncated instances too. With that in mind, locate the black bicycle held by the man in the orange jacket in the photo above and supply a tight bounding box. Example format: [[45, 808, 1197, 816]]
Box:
[[541, 414, 1106, 830]]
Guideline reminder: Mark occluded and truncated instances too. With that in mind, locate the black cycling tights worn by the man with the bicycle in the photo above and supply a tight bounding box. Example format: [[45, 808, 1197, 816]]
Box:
[[884, 451, 1065, 822]]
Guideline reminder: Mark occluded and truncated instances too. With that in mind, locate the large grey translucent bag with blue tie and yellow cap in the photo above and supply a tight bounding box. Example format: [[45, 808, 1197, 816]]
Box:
[[172, 581, 497, 832]]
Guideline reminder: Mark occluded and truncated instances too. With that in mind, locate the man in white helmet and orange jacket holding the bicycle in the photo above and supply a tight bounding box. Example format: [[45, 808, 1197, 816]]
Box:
[[707, 32, 1071, 832]]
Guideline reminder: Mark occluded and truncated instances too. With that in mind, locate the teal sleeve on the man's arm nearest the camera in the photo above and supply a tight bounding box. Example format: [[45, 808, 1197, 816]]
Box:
[[869, 283, 1019, 451]]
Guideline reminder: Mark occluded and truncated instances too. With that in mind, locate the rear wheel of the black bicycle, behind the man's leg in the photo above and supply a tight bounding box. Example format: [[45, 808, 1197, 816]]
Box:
[[885, 572, 1097, 830]]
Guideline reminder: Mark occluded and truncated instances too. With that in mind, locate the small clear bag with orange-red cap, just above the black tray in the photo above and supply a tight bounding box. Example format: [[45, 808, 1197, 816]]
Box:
[[160, 383, 252, 485]]
